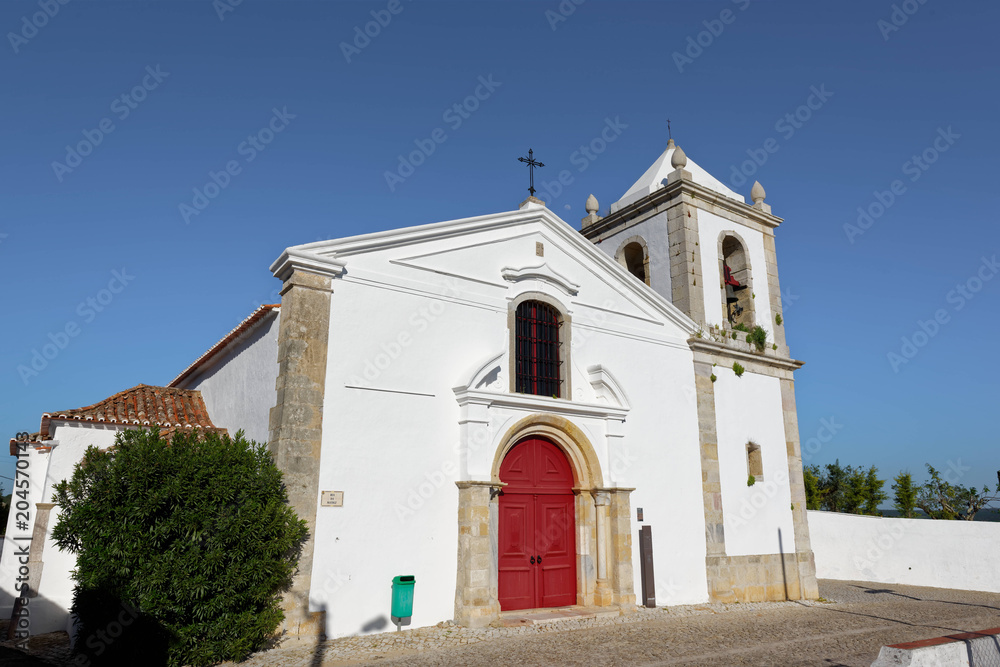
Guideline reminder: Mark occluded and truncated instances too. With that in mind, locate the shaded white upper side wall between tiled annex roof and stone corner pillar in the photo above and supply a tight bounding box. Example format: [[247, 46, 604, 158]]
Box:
[[177, 310, 280, 443]]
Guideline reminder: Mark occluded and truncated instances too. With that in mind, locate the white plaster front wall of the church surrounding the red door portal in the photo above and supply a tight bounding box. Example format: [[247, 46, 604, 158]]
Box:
[[311, 217, 712, 636]]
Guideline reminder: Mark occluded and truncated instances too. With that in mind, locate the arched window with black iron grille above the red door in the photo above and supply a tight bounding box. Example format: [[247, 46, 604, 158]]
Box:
[[514, 301, 562, 398]]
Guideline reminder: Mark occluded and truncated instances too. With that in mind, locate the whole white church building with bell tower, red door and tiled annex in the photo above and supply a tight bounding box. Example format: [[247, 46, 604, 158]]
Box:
[[0, 141, 818, 636]]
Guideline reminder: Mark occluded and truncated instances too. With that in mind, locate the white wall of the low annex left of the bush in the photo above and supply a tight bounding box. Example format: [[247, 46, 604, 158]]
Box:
[[0, 420, 121, 634]]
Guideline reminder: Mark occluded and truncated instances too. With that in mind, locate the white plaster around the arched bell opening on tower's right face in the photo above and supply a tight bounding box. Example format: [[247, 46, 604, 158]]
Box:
[[698, 210, 774, 341]]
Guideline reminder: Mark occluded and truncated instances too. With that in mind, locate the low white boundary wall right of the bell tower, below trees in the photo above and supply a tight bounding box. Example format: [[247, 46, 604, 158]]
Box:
[[808, 511, 1000, 593]]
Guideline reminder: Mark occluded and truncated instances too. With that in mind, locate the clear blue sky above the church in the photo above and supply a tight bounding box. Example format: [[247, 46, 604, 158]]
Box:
[[0, 0, 1000, 496]]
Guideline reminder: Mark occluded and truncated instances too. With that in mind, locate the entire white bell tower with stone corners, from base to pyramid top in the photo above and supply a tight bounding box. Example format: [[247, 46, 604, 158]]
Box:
[[581, 139, 819, 602]]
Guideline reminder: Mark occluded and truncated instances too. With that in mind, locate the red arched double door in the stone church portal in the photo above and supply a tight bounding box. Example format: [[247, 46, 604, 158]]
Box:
[[498, 438, 576, 611]]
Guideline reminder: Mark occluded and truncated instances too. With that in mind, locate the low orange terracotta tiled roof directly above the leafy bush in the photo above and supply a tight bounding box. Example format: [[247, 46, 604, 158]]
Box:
[[39, 384, 226, 440]]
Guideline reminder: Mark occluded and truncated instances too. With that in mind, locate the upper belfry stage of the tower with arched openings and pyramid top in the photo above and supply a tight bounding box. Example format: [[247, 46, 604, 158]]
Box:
[[581, 139, 787, 354]]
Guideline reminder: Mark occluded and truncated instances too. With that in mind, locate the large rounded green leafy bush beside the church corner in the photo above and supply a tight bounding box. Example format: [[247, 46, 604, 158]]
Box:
[[53, 429, 307, 666]]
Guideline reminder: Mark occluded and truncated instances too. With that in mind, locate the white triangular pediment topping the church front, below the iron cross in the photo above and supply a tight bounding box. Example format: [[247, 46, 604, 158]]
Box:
[[271, 205, 697, 334]]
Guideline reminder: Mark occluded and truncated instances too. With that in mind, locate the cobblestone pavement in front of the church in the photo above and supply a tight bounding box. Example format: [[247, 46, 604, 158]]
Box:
[[227, 581, 1000, 667]]
